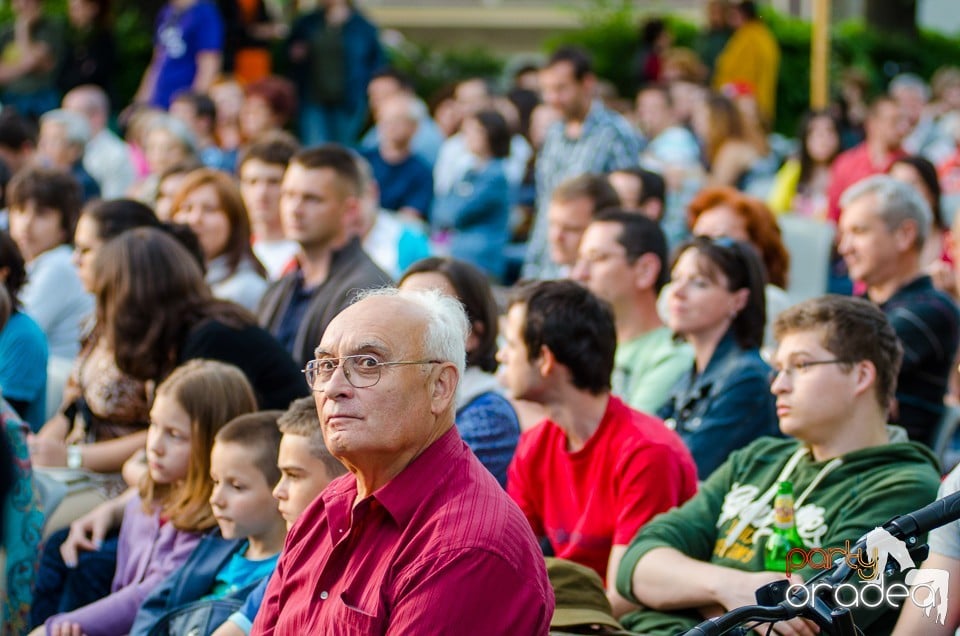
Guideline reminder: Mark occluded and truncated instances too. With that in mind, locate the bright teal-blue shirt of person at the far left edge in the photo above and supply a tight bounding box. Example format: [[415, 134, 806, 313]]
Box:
[[0, 311, 47, 431]]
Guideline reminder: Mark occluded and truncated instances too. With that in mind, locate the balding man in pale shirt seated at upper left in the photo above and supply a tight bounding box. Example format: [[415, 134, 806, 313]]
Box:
[[63, 84, 137, 199]]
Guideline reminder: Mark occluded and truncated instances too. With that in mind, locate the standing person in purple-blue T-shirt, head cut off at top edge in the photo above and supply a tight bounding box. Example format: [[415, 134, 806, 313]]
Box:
[[134, 0, 224, 109]]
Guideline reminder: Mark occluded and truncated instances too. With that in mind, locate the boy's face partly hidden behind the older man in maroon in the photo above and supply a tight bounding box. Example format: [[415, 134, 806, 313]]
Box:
[[213, 397, 347, 636]]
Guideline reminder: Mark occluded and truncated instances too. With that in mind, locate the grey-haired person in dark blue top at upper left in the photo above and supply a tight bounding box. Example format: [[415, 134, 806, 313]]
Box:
[[37, 108, 100, 203]]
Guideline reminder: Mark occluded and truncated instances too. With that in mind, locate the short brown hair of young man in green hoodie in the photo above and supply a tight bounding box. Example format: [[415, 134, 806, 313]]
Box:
[[773, 295, 903, 409]]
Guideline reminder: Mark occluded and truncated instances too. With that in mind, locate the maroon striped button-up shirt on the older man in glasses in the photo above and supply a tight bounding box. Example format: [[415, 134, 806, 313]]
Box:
[[252, 427, 554, 636]]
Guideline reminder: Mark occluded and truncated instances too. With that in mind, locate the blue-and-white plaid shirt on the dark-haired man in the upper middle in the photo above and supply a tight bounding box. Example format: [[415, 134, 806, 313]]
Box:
[[523, 101, 640, 278]]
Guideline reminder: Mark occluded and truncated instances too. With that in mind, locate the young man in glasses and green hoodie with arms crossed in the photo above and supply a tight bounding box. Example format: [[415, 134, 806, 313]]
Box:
[[617, 296, 939, 636]]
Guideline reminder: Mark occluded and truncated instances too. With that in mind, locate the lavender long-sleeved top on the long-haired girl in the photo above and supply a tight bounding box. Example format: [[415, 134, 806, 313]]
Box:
[[46, 520, 200, 636]]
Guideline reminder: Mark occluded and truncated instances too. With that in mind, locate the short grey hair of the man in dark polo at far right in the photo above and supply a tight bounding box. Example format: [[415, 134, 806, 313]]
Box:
[[840, 174, 933, 249]]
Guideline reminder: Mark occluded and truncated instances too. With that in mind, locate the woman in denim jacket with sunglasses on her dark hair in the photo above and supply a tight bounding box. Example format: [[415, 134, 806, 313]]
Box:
[[657, 237, 779, 480]]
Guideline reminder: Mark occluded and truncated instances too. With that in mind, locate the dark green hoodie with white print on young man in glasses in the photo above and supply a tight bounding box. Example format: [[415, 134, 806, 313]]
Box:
[[617, 427, 940, 636]]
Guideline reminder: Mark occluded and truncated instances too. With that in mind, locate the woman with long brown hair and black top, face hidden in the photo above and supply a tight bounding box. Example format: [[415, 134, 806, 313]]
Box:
[[94, 228, 307, 409]]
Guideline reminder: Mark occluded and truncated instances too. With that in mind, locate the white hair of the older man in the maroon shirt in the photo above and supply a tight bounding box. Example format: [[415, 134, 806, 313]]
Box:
[[356, 287, 470, 378]]
